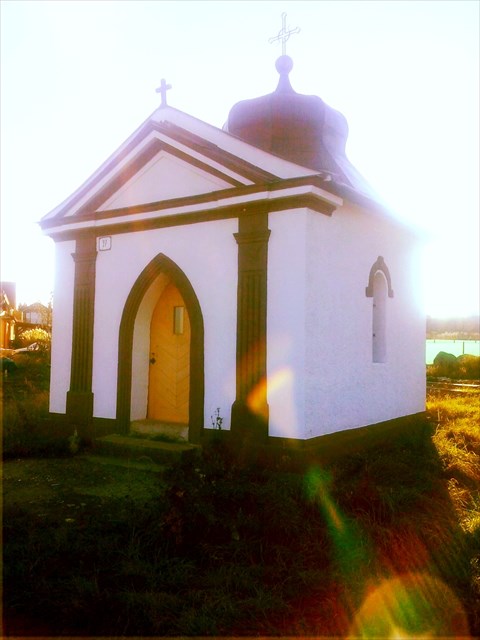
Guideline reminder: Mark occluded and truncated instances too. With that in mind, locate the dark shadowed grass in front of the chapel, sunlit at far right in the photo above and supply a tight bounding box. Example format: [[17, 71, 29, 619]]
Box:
[[4, 360, 480, 637]]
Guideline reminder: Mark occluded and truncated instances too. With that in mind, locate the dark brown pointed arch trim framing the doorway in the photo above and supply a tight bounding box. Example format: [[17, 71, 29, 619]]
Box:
[[117, 254, 205, 443]]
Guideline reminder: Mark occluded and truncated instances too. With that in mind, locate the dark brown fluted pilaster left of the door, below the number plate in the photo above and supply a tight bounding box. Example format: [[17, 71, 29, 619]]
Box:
[[67, 233, 97, 429]]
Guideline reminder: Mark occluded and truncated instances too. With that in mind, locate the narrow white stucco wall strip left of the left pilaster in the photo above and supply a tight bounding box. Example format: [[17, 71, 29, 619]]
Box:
[[50, 240, 75, 413]]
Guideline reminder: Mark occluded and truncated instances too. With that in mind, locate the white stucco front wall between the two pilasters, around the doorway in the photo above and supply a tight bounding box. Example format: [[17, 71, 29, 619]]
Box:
[[93, 220, 238, 429]]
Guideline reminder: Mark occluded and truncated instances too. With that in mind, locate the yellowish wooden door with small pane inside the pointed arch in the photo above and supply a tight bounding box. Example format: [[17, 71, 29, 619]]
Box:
[[147, 284, 190, 424]]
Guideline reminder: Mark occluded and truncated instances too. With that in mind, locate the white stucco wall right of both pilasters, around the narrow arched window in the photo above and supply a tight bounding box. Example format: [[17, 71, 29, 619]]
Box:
[[267, 204, 425, 439]]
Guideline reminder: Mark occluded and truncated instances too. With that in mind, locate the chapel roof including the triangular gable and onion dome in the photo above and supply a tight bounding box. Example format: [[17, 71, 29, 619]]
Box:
[[41, 56, 404, 234]]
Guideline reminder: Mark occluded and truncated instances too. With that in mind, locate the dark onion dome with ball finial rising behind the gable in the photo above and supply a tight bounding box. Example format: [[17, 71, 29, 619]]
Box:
[[225, 55, 376, 194]]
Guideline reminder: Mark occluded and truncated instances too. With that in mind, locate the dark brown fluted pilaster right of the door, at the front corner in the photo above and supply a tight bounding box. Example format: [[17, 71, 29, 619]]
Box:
[[231, 209, 270, 442]]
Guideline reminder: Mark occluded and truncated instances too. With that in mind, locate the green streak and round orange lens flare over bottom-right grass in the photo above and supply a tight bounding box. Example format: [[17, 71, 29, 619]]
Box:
[[305, 466, 470, 640]]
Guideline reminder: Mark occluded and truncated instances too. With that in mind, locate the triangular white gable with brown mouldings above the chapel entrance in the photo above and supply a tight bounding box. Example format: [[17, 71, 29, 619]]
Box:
[[42, 114, 284, 227]]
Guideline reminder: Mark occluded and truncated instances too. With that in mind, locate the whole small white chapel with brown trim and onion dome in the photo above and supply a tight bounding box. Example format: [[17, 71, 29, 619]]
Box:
[[40, 56, 425, 444]]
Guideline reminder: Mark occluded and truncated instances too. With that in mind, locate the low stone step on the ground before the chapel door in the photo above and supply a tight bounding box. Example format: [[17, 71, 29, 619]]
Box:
[[94, 434, 201, 464]]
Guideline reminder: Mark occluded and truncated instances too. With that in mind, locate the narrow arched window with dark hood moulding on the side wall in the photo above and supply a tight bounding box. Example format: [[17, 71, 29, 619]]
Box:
[[365, 256, 393, 362]]
